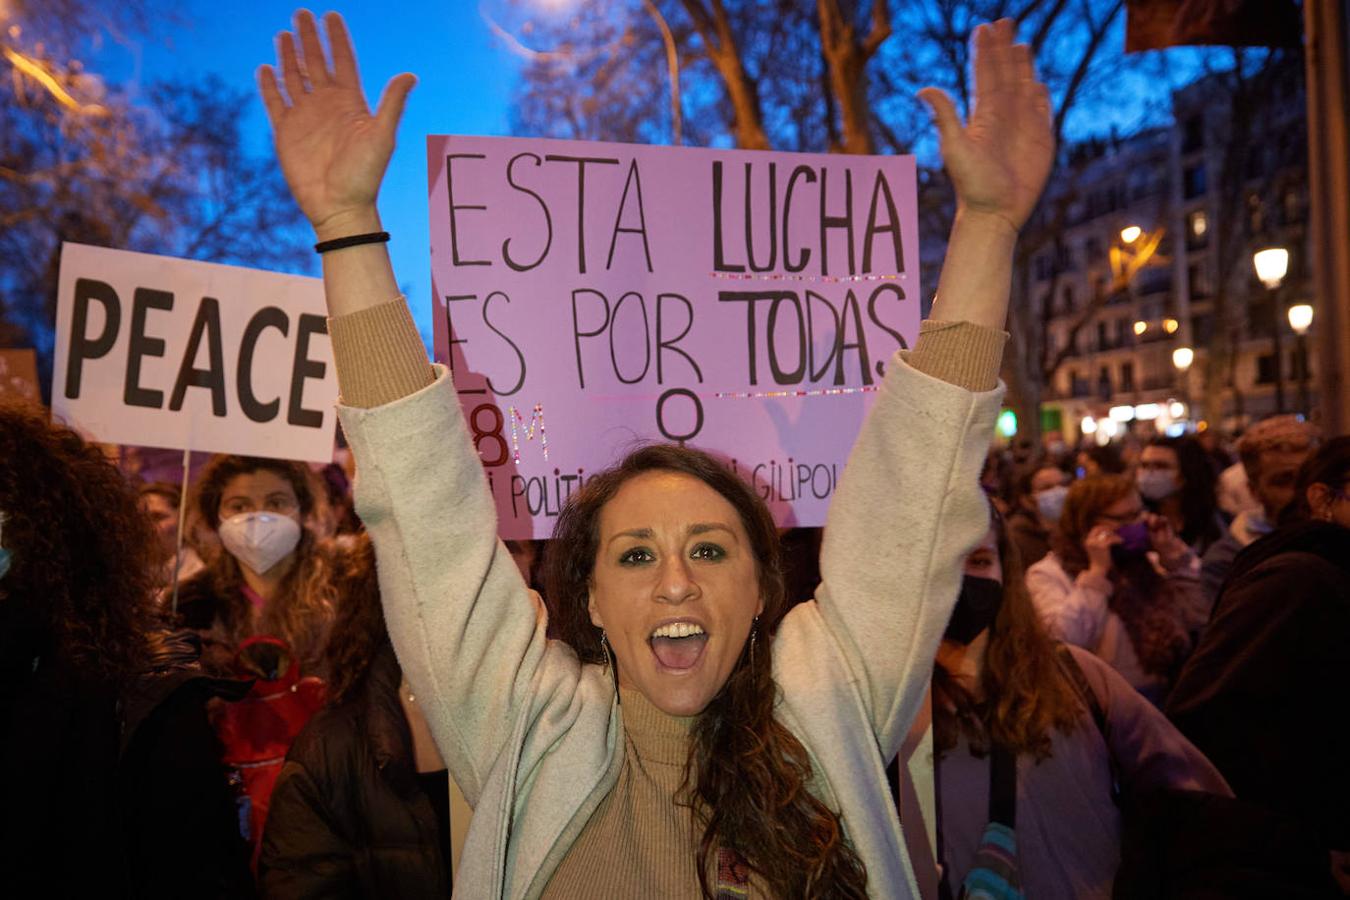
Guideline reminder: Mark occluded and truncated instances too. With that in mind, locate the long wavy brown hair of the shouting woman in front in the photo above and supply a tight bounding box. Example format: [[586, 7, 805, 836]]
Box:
[[544, 444, 867, 897]]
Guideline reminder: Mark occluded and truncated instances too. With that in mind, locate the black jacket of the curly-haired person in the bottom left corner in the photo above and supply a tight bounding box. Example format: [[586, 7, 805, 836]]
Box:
[[0, 626, 252, 900]]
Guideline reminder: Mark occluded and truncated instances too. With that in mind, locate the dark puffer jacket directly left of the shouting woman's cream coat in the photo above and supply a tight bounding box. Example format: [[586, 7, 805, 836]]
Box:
[[258, 644, 450, 900]]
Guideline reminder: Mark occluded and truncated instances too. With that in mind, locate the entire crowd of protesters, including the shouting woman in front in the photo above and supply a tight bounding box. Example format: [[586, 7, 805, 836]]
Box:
[[0, 12, 1350, 899]]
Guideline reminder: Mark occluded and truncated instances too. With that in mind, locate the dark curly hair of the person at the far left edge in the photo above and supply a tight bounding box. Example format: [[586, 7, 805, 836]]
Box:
[[0, 406, 157, 684]]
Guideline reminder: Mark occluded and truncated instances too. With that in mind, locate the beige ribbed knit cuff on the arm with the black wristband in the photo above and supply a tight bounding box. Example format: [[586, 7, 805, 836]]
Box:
[[328, 297, 435, 409]]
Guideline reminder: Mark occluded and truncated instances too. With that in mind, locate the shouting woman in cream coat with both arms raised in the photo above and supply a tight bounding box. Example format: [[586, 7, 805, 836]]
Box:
[[261, 12, 1053, 897]]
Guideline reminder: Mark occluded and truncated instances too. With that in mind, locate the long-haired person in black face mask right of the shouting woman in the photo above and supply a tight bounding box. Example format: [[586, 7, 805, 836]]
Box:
[[933, 517, 1231, 900]]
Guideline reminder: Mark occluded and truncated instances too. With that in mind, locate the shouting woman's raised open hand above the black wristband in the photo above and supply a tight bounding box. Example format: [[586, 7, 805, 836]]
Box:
[[258, 9, 417, 240]]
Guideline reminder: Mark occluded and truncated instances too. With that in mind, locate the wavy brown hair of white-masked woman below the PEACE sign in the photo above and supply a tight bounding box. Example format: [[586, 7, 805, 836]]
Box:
[[184, 456, 338, 673]]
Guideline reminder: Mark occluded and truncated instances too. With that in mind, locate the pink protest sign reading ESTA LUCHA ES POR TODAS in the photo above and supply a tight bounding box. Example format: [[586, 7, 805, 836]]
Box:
[[427, 135, 919, 537]]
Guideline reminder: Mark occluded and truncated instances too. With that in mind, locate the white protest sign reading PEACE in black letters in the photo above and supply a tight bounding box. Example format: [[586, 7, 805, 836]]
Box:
[[51, 244, 338, 461]]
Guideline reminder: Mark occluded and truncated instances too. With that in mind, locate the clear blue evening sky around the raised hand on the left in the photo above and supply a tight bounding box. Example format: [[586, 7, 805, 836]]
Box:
[[96, 0, 517, 344]]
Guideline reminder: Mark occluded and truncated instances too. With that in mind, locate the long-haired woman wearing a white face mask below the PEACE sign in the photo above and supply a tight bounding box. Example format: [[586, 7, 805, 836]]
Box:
[[177, 456, 335, 676]]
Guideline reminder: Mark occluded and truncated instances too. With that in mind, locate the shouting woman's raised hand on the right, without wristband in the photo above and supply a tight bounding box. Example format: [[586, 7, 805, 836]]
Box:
[[919, 19, 1054, 231]]
